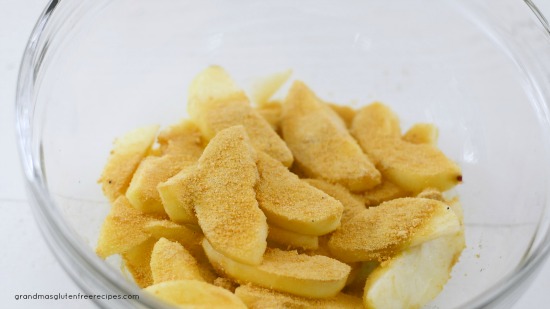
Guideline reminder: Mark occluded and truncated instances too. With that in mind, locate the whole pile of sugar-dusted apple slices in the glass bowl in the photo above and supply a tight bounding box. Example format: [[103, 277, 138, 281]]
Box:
[[96, 66, 464, 308]]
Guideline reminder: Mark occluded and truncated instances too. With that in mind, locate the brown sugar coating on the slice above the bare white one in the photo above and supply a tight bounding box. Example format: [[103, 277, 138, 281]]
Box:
[[329, 198, 441, 262]]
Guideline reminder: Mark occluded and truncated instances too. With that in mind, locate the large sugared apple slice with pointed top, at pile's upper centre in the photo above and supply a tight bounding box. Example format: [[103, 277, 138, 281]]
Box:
[[281, 81, 380, 191]]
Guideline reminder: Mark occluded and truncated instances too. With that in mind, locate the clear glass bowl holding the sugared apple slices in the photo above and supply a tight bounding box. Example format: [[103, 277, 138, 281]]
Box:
[[17, 0, 550, 308]]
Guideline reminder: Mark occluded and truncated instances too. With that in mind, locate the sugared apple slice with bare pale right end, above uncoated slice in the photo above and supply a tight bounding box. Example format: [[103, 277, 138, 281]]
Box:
[[328, 198, 460, 262]]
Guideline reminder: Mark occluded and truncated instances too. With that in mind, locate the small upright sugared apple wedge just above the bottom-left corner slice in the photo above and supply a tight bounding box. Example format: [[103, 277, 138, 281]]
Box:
[[151, 238, 204, 284]]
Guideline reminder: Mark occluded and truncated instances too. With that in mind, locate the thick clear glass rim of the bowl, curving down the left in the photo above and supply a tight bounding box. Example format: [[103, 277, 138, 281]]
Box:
[[15, 0, 550, 308]]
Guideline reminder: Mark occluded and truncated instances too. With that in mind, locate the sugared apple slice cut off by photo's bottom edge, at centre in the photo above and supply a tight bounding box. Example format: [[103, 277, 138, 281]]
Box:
[[235, 284, 363, 309]]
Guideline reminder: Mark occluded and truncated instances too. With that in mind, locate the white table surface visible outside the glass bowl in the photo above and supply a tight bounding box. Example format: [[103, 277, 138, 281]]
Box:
[[0, 0, 550, 309]]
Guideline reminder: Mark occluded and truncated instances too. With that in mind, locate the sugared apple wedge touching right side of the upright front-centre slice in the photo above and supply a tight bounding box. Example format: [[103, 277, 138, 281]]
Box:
[[256, 152, 343, 236]]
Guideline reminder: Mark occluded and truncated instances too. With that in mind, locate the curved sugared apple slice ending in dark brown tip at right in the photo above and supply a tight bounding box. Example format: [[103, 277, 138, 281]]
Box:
[[350, 103, 462, 194]]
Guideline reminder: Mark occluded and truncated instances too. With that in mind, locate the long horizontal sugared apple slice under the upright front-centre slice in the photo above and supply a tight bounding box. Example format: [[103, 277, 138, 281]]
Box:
[[203, 239, 350, 298]]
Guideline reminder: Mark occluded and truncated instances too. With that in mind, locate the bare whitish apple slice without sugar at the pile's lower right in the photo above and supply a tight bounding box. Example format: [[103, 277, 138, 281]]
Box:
[[363, 231, 465, 308]]
